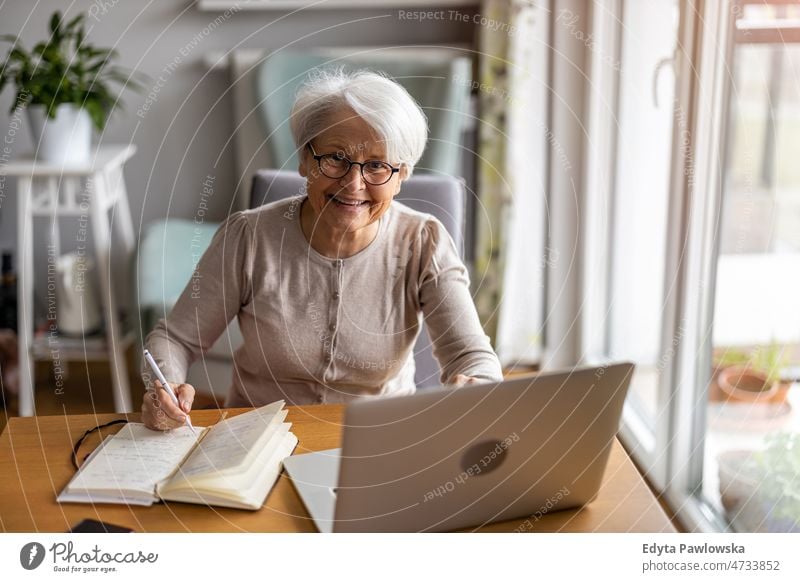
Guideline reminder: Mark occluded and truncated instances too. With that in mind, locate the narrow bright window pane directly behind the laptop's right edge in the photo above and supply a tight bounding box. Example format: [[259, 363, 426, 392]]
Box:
[[583, 0, 686, 486]]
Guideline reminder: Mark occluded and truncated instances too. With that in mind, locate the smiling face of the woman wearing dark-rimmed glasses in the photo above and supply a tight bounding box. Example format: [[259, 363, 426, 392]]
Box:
[[299, 109, 406, 244]]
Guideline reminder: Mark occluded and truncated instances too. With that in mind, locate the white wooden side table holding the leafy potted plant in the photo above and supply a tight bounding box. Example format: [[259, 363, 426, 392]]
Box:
[[0, 145, 136, 416]]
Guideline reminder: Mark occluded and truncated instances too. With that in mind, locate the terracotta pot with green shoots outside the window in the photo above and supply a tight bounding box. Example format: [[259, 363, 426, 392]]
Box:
[[710, 342, 790, 404]]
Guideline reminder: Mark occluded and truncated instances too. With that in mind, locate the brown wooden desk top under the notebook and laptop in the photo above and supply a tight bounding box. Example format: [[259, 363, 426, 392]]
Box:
[[0, 405, 674, 532]]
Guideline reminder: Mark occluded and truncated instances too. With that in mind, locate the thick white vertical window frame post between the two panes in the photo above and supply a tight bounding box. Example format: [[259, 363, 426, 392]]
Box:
[[664, 0, 735, 531]]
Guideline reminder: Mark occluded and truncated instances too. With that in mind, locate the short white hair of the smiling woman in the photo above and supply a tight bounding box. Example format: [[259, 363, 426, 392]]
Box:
[[290, 67, 428, 176]]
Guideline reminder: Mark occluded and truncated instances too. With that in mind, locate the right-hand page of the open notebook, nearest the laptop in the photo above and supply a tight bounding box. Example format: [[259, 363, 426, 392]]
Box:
[[174, 401, 287, 478]]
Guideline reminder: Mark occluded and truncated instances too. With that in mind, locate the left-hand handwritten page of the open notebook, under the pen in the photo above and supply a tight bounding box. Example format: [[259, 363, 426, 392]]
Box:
[[69, 423, 204, 494]]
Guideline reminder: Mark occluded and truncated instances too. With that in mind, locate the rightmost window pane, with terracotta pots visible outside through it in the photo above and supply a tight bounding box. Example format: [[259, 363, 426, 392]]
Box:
[[702, 3, 800, 532]]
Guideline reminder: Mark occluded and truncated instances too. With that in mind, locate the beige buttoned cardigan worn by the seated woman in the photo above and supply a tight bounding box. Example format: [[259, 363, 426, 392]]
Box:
[[142, 197, 502, 406]]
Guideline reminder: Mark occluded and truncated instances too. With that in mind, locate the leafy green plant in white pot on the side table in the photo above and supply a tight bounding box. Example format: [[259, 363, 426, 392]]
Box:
[[0, 11, 140, 164]]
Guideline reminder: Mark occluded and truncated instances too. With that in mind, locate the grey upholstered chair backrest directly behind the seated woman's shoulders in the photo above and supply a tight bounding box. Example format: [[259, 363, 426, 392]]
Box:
[[250, 170, 467, 388]]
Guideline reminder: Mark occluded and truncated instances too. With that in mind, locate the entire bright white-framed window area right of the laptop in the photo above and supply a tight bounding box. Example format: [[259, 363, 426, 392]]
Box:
[[581, 0, 800, 531]]
